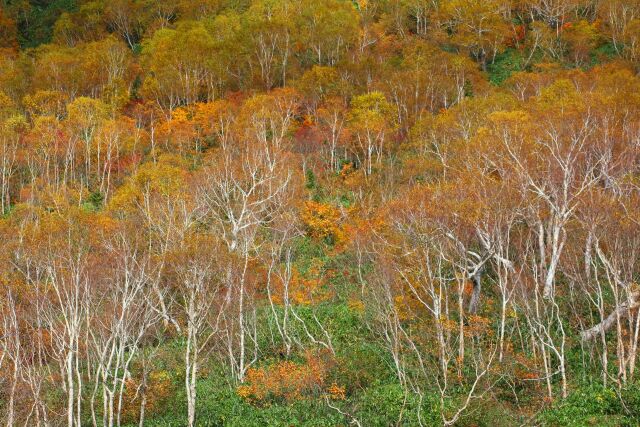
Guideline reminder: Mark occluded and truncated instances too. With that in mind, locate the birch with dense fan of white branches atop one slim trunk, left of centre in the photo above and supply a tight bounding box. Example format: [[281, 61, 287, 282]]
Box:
[[198, 91, 302, 381]]
